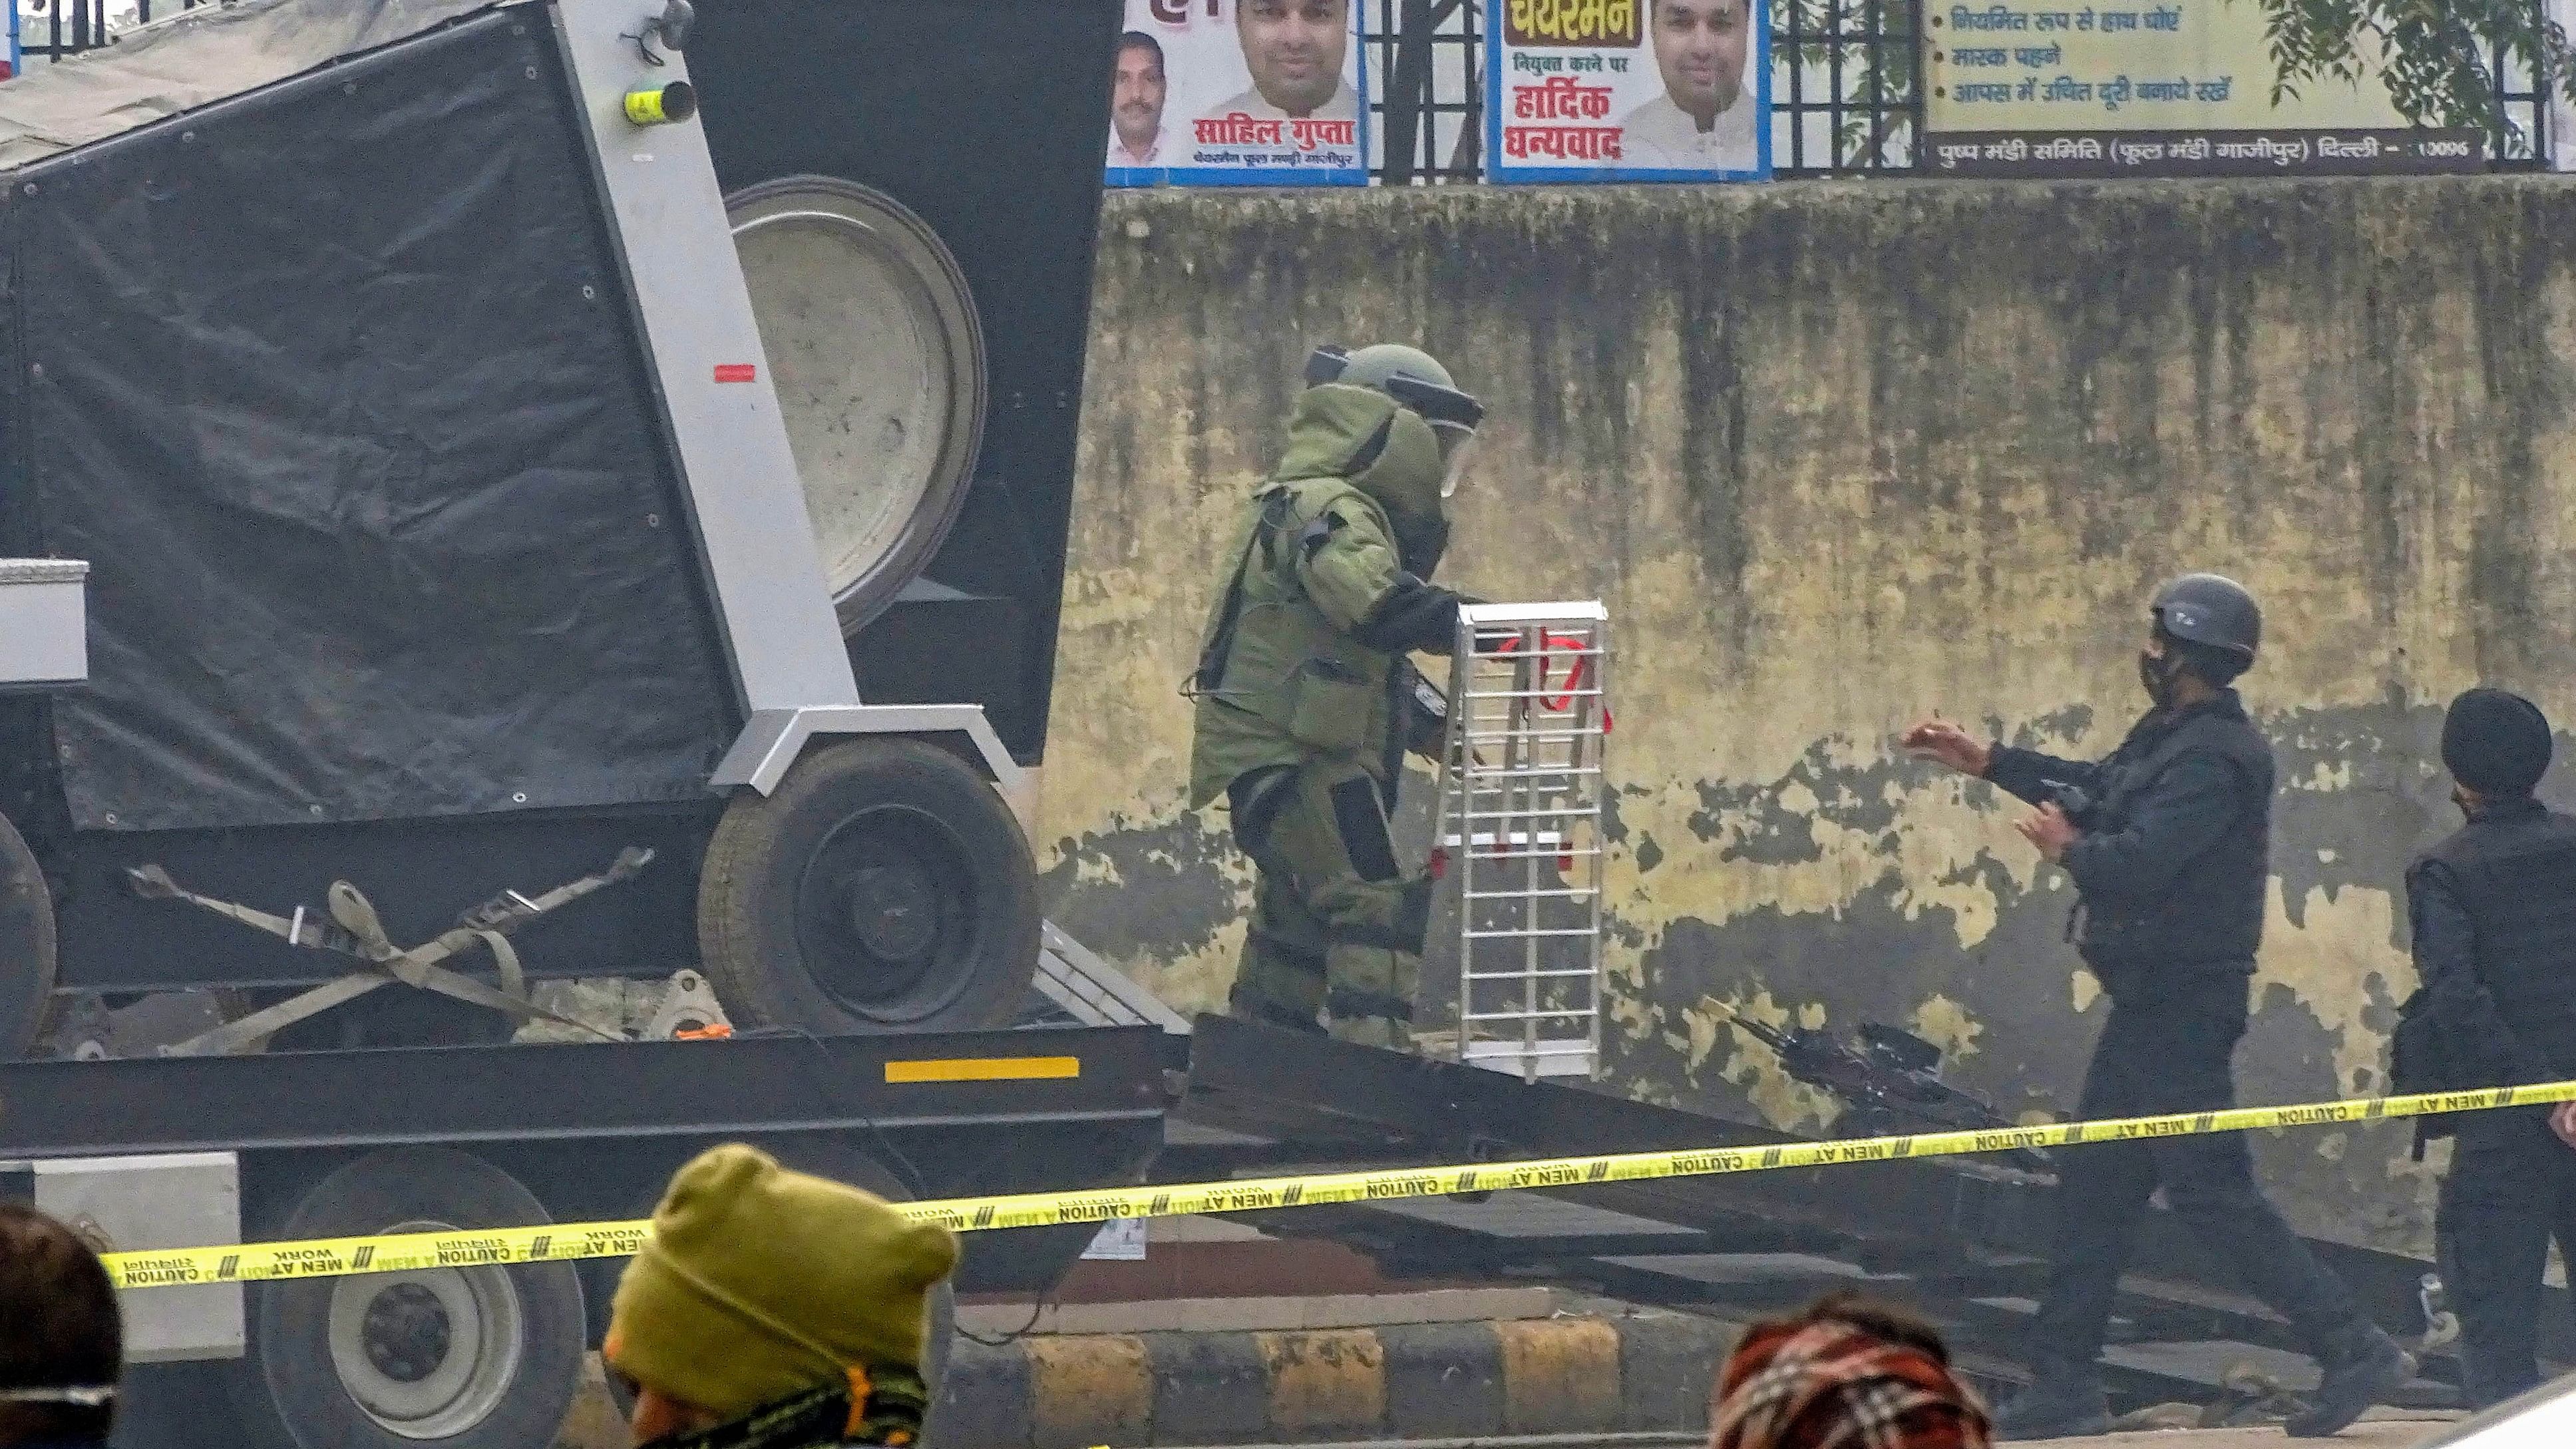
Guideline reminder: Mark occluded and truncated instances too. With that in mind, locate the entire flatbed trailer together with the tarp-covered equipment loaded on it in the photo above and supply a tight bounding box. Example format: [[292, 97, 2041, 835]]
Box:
[[0, 0, 1165, 1449]]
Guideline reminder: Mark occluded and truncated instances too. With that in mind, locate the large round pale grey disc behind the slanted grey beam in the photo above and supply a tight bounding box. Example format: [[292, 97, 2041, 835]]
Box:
[[724, 175, 987, 634]]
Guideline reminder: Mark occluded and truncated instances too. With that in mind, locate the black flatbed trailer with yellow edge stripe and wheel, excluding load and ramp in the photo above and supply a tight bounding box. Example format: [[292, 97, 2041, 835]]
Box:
[[0, 1026, 1175, 1449]]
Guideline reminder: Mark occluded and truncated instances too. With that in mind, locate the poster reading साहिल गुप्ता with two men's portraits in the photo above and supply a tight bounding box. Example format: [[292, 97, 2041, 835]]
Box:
[[1108, 0, 1368, 186]]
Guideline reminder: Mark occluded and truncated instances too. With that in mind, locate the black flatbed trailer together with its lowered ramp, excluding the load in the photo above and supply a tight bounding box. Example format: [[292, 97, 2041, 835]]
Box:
[[0, 1005, 2524, 1449]]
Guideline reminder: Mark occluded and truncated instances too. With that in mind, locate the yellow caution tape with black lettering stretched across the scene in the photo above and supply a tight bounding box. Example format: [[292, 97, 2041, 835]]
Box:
[[91, 1080, 2576, 1289]]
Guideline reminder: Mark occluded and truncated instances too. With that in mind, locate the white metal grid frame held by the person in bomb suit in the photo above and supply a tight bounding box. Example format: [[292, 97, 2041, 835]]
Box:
[[1432, 601, 1610, 1080]]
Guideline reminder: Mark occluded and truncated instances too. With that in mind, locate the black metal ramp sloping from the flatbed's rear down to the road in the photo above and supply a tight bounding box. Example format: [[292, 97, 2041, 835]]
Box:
[[1154, 1018, 2503, 1410]]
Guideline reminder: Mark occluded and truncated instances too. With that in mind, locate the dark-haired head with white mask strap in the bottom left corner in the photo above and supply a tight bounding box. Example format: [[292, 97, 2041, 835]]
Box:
[[0, 1201, 124, 1449]]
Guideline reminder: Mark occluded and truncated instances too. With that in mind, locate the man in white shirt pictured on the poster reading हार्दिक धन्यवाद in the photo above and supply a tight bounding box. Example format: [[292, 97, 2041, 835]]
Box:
[[1620, 0, 1765, 170]]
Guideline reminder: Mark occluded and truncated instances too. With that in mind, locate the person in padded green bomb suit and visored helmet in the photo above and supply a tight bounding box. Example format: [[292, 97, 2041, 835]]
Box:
[[1188, 343, 1484, 1050]]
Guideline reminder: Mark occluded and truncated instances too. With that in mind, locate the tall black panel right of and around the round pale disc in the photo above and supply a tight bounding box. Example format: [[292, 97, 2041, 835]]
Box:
[[688, 0, 1121, 763]]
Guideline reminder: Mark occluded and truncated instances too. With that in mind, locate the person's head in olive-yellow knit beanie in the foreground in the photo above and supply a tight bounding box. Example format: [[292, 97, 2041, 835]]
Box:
[[600, 1142, 958, 1449]]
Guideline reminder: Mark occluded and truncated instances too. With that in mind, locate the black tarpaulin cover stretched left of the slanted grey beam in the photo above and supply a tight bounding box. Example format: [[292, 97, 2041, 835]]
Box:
[[0, 8, 734, 830]]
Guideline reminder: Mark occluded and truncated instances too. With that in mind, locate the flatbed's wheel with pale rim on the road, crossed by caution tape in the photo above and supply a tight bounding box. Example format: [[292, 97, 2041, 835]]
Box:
[[234, 1147, 585, 1449]]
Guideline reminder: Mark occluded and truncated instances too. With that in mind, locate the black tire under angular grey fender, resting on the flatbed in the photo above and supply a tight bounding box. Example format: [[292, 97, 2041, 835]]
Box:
[[698, 735, 1041, 1034]]
